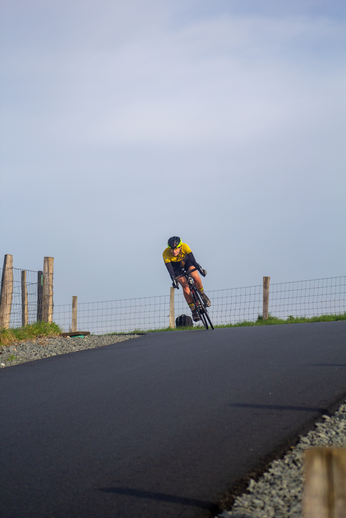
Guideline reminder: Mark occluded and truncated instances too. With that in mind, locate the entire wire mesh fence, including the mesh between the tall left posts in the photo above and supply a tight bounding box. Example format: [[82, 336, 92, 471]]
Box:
[[0, 262, 346, 334]]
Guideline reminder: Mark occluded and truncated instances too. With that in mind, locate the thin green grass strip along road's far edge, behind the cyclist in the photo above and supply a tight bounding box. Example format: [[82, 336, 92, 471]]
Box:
[[113, 313, 346, 334]]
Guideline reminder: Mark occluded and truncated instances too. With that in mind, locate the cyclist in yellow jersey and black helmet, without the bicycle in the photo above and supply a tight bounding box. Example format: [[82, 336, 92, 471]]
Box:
[[162, 236, 211, 322]]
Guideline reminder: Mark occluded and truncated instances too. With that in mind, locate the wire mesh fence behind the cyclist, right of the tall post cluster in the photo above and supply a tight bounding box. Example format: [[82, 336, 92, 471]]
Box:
[[54, 276, 346, 334]]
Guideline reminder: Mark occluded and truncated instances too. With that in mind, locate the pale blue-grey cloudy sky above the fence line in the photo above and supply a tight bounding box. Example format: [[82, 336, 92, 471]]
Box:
[[0, 0, 346, 305]]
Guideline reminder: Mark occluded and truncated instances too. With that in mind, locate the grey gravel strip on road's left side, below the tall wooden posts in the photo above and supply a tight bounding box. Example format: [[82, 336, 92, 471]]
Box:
[[0, 334, 141, 369]]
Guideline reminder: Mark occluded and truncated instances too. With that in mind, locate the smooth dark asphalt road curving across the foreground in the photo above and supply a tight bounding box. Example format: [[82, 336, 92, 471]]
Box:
[[0, 322, 346, 518]]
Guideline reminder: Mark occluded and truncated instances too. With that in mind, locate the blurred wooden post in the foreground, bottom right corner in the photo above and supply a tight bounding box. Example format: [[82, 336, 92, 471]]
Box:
[[303, 448, 346, 518]]
